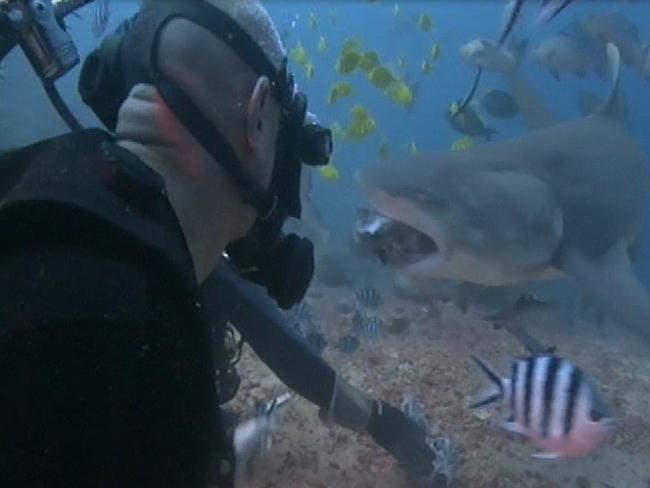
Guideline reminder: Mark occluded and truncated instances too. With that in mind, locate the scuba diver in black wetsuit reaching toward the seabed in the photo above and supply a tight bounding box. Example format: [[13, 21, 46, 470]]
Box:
[[0, 0, 451, 487]]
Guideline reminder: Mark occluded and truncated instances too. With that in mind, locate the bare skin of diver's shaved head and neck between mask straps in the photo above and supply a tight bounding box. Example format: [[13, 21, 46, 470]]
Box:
[[110, 0, 284, 279]]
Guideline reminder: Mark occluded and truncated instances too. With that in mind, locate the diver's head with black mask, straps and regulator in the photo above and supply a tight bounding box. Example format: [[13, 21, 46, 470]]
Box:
[[104, 0, 332, 304]]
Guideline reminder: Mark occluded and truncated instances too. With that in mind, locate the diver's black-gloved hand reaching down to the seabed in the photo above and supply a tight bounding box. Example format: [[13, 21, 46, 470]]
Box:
[[367, 401, 457, 487]]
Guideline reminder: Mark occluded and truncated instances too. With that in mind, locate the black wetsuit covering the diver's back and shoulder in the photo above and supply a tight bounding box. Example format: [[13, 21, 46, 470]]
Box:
[[0, 130, 232, 488]]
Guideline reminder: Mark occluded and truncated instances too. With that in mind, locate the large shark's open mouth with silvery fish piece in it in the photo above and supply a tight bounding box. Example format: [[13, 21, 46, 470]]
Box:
[[355, 209, 440, 266]]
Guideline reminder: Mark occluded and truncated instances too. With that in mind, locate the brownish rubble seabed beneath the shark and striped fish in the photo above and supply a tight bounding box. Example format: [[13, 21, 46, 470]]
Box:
[[227, 286, 650, 488]]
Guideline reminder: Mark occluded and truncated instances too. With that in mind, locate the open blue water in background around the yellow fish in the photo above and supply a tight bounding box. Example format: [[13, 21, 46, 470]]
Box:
[[0, 0, 650, 285]]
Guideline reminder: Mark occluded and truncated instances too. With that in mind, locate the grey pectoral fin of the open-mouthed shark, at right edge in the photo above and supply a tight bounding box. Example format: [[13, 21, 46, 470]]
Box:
[[559, 242, 650, 340]]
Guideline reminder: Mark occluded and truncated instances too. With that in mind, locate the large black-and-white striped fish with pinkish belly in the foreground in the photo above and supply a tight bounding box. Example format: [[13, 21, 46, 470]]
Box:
[[470, 355, 618, 459]]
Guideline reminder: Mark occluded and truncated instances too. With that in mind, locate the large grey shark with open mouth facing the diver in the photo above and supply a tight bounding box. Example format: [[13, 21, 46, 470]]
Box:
[[357, 44, 650, 338]]
